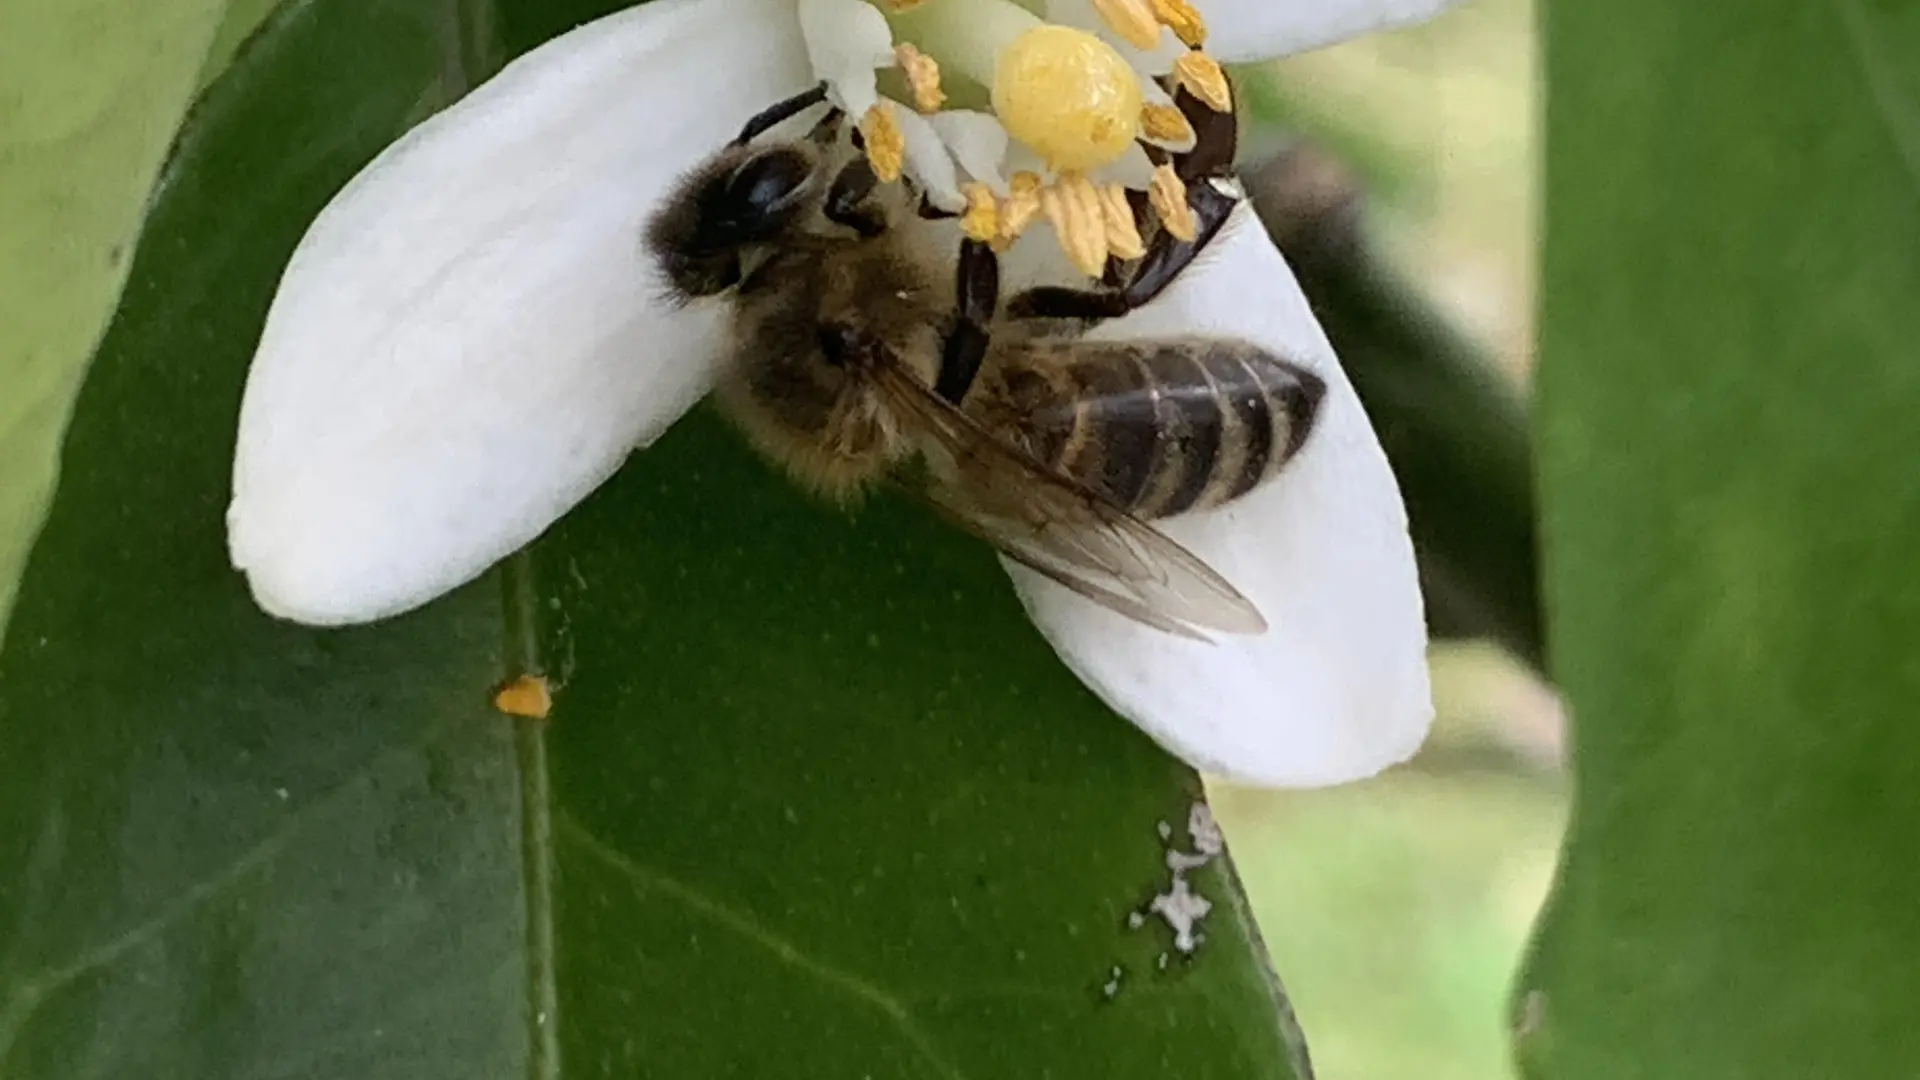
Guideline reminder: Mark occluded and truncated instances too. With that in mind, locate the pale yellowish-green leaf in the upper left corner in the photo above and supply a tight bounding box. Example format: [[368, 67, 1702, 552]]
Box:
[[0, 0, 238, 626]]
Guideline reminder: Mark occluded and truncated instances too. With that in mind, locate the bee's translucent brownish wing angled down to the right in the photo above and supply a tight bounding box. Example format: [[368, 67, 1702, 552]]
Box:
[[874, 353, 1267, 640]]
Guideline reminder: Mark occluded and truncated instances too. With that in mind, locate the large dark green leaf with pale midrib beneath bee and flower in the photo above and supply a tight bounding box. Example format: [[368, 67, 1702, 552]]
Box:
[[0, 0, 1304, 1080]]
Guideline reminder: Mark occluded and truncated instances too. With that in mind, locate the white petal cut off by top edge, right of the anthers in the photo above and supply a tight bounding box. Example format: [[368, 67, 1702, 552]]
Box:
[[1192, 0, 1453, 63]]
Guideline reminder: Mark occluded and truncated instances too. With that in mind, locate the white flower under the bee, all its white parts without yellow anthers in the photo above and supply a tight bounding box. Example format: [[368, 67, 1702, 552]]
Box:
[[228, 0, 1446, 786]]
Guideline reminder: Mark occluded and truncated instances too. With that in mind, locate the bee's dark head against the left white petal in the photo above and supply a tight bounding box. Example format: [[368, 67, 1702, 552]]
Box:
[[647, 142, 820, 298]]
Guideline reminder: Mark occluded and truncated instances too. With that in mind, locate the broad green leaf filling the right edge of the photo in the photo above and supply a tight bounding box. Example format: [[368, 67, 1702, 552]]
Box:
[[1517, 0, 1920, 1080]]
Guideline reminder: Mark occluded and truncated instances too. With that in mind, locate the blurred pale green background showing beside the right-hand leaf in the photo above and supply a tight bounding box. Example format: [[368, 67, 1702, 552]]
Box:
[[1215, 0, 1567, 1080]]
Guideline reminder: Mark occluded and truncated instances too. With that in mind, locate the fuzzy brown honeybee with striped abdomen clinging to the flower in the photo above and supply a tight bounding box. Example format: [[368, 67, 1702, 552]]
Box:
[[645, 90, 1325, 640]]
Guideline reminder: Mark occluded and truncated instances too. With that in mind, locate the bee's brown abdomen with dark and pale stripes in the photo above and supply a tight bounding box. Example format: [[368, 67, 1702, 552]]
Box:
[[985, 338, 1327, 519]]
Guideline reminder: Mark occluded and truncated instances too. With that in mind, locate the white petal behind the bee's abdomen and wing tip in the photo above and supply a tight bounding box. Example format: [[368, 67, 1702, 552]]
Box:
[[1008, 206, 1432, 786]]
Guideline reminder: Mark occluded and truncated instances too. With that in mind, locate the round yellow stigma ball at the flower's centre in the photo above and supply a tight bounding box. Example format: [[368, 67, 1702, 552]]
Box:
[[993, 25, 1140, 173]]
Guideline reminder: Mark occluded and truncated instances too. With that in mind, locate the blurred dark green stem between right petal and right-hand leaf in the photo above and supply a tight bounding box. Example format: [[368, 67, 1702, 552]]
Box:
[[1242, 147, 1546, 671]]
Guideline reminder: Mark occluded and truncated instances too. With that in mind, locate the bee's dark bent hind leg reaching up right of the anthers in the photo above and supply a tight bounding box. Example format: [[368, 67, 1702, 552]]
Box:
[[1006, 88, 1240, 323]]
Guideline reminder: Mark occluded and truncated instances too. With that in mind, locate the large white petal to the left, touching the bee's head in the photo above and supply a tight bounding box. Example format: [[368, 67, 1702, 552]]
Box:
[[228, 0, 810, 625]]
